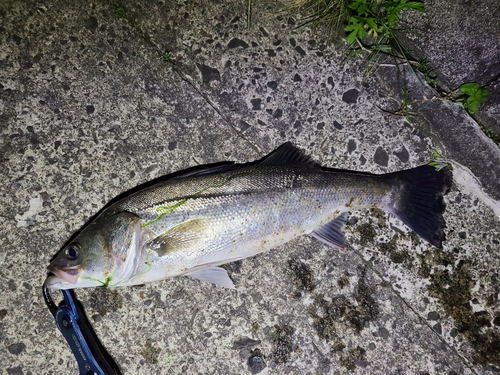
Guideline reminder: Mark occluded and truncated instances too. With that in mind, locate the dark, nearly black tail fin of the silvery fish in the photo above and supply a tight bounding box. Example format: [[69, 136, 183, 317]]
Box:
[[384, 165, 453, 248]]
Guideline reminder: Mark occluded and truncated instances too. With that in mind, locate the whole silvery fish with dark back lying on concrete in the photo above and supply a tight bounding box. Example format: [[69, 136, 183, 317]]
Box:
[[44, 143, 453, 289]]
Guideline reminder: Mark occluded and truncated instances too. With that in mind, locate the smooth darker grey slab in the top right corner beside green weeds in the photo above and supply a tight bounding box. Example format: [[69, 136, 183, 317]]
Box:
[[402, 0, 500, 140]]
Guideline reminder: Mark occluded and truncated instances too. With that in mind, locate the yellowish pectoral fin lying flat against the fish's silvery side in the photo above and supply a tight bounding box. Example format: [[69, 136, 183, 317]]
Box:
[[147, 218, 208, 257]]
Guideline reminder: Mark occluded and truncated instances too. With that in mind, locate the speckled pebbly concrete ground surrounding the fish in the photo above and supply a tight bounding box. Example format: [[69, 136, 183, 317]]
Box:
[[0, 0, 500, 375]]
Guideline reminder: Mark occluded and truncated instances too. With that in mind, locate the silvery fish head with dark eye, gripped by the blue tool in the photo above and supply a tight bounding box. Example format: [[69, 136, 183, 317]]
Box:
[[45, 212, 141, 289]]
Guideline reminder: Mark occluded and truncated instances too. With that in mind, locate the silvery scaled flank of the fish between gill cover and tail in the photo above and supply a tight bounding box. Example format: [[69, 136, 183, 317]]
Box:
[[112, 167, 390, 282]]
